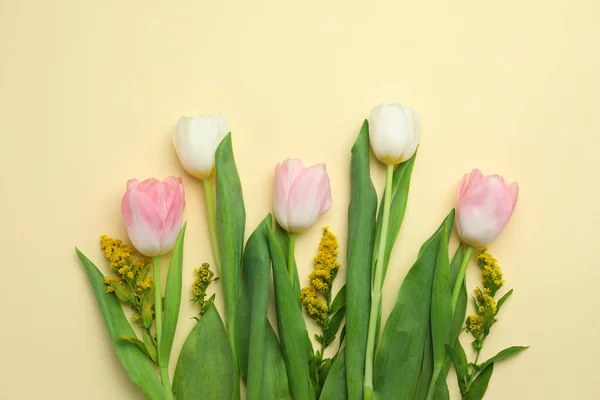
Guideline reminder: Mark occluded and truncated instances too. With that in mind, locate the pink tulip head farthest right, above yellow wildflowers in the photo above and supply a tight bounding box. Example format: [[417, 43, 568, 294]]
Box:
[[456, 169, 519, 247]]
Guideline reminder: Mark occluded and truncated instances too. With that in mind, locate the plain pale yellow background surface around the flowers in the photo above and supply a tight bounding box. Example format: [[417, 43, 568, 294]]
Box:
[[0, 0, 600, 400]]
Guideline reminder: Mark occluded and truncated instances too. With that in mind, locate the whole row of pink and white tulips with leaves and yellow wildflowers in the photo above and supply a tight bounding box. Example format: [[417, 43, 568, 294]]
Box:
[[77, 103, 526, 400]]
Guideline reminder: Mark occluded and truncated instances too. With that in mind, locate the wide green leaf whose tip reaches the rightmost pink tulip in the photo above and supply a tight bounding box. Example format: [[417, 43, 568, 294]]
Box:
[[370, 210, 454, 399]]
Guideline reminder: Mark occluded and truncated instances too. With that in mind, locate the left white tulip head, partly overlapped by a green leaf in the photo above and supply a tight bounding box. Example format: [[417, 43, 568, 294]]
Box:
[[173, 114, 229, 179]]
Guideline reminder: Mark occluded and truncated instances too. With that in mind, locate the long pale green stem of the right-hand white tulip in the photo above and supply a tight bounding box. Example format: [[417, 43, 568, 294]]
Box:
[[364, 165, 394, 400]]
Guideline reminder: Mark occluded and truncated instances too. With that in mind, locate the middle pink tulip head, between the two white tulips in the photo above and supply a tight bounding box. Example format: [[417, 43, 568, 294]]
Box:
[[273, 159, 331, 233]]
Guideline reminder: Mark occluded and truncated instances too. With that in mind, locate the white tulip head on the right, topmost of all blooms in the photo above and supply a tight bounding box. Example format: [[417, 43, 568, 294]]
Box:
[[369, 102, 421, 164]]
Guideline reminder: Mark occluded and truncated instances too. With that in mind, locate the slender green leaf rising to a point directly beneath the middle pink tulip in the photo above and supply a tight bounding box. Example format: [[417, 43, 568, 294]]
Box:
[[268, 222, 315, 400]]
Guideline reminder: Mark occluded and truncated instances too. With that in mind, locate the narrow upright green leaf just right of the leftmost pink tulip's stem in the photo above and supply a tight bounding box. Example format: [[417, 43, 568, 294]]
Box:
[[158, 224, 186, 366]]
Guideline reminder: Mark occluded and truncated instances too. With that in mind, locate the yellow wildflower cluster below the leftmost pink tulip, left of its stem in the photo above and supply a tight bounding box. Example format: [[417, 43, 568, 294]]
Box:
[[100, 235, 154, 328]]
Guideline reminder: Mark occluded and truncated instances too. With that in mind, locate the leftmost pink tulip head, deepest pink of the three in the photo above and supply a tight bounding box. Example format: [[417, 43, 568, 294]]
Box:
[[121, 176, 185, 257]]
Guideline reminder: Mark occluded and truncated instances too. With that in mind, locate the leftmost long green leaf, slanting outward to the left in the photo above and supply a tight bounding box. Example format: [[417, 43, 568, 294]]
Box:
[[75, 249, 166, 400]]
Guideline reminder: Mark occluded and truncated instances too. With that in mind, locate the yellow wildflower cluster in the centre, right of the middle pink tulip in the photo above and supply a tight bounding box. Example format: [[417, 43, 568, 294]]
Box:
[[300, 227, 340, 326]]
